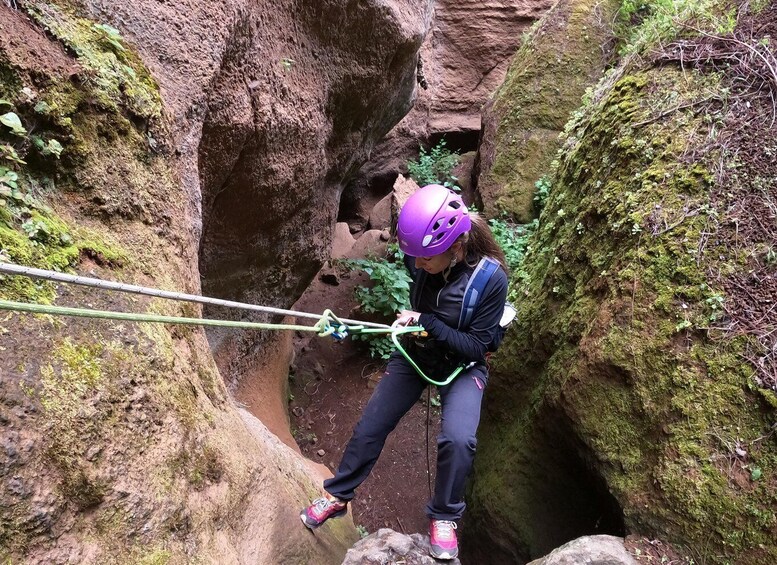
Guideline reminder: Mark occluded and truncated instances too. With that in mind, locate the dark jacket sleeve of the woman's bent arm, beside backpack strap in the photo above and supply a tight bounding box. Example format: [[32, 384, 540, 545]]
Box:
[[418, 269, 507, 362]]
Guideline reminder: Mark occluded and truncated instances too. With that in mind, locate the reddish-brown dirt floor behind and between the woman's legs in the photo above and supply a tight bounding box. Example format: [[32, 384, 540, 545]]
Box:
[[289, 262, 440, 534]]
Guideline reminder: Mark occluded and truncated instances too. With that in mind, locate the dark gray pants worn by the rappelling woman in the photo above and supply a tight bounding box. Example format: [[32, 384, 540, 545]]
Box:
[[324, 354, 487, 520]]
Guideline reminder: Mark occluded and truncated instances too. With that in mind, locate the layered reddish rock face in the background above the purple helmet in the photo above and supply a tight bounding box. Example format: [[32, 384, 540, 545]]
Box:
[[342, 0, 554, 227]]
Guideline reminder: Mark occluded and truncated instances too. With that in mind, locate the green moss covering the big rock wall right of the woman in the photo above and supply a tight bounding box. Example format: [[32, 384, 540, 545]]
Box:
[[473, 56, 777, 563]]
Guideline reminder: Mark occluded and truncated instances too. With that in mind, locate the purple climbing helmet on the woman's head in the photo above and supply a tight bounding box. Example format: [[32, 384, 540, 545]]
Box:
[[397, 184, 472, 257]]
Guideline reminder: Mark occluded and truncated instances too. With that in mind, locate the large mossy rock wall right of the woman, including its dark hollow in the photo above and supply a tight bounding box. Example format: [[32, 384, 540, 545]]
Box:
[[462, 2, 777, 564]]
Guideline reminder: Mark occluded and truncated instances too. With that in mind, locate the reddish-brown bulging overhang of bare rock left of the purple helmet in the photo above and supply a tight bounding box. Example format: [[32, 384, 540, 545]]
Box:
[[62, 0, 432, 388]]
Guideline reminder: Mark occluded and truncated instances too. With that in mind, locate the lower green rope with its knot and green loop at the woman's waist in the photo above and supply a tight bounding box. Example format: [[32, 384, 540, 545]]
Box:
[[0, 300, 464, 386]]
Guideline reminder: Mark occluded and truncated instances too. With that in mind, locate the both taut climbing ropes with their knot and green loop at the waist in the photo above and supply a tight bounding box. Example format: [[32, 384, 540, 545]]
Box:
[[0, 262, 465, 386]]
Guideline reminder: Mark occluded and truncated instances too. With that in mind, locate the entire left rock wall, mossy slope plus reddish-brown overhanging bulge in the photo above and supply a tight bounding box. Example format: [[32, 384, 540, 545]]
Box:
[[0, 0, 431, 563]]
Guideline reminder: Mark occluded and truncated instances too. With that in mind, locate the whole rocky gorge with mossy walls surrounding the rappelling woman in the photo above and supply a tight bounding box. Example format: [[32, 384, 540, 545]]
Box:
[[0, 0, 777, 565]]
